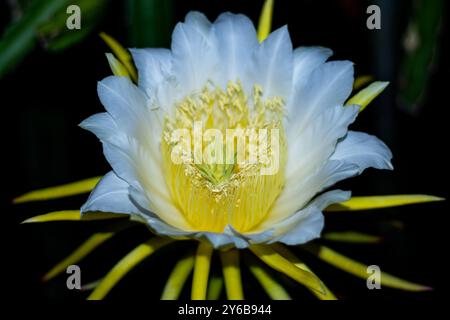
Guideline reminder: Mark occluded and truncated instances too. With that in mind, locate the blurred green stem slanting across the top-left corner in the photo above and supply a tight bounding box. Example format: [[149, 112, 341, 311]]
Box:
[[0, 0, 68, 78]]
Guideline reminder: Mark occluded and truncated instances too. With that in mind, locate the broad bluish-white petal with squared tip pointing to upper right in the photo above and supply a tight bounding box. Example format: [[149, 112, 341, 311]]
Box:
[[287, 61, 353, 139]]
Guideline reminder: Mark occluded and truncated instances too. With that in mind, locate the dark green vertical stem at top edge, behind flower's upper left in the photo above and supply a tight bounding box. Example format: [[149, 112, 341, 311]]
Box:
[[125, 0, 173, 47]]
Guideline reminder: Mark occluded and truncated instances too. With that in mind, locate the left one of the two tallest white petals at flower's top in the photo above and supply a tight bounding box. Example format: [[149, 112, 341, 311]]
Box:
[[172, 12, 218, 98]]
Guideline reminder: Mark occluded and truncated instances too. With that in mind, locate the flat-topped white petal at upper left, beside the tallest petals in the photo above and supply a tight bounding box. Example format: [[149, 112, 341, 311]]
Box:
[[130, 48, 172, 97]]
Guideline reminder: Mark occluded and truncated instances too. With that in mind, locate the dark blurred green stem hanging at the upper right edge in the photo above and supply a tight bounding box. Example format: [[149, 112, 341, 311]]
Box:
[[400, 0, 444, 113]]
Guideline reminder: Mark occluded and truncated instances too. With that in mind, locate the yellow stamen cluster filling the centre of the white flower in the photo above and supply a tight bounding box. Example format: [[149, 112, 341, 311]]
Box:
[[161, 82, 286, 232]]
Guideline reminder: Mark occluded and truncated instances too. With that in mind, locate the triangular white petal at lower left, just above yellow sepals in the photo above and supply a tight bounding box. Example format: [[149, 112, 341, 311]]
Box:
[[81, 171, 140, 214]]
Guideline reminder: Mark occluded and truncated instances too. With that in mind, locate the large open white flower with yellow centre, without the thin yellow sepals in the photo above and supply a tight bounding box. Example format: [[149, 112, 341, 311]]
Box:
[[81, 12, 392, 248]]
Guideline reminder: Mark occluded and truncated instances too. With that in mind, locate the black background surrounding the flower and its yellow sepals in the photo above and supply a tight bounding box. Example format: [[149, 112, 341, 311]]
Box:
[[0, 0, 450, 301]]
